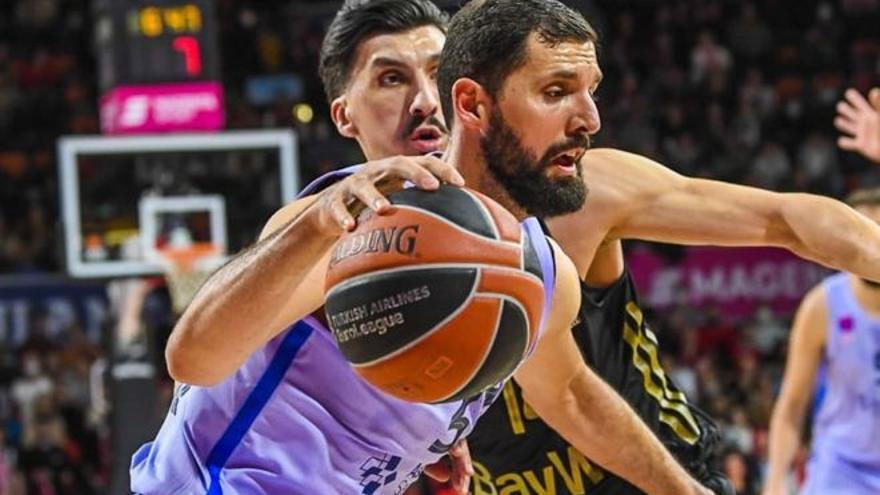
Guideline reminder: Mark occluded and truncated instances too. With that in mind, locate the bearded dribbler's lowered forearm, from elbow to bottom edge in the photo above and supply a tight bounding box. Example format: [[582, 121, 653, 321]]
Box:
[[527, 372, 704, 495]]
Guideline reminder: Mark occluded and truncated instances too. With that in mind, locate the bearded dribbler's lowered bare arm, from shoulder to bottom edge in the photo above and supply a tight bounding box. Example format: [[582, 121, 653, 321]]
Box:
[[514, 242, 711, 495]]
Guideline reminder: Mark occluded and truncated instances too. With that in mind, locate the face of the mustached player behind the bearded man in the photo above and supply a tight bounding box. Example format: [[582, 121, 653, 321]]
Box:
[[333, 26, 447, 160]]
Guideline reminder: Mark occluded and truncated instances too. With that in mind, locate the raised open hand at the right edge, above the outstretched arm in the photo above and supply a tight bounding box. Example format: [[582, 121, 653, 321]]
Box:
[[834, 88, 880, 163]]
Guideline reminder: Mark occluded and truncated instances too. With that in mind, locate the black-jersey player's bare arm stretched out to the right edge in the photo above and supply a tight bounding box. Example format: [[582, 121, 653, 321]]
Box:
[[568, 149, 880, 280]]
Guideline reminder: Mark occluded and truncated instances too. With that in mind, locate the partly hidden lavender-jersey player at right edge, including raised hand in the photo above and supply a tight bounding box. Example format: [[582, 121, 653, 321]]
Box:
[[762, 89, 880, 495]]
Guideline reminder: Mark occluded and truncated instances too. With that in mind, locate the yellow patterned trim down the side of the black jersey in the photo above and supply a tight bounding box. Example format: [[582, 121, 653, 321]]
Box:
[[623, 301, 700, 445]]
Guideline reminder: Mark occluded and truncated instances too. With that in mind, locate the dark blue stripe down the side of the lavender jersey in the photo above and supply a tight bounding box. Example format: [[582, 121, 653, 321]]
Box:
[[206, 321, 312, 495]]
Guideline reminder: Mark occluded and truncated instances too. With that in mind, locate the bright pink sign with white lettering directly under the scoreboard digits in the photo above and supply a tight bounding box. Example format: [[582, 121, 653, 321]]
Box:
[[101, 82, 224, 134]]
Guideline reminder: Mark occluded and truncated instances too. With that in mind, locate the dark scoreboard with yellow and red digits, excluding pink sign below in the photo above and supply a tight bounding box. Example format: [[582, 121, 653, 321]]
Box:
[[96, 0, 220, 91]]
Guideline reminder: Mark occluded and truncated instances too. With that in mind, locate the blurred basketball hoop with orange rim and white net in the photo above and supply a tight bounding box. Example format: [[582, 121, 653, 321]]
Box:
[[157, 242, 223, 315]]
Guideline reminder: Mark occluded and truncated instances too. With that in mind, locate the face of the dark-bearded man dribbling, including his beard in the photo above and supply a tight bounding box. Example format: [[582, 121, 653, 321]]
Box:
[[481, 34, 602, 217]]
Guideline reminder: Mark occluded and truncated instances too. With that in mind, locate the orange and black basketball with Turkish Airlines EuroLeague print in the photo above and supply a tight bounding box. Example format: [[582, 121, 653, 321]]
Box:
[[325, 185, 544, 403]]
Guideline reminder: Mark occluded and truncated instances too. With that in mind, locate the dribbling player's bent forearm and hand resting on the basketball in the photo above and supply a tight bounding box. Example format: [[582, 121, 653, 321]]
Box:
[[165, 156, 464, 386]]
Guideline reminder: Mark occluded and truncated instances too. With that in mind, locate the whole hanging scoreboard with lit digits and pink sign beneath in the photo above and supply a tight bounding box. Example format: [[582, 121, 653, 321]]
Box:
[[93, 0, 225, 134]]
